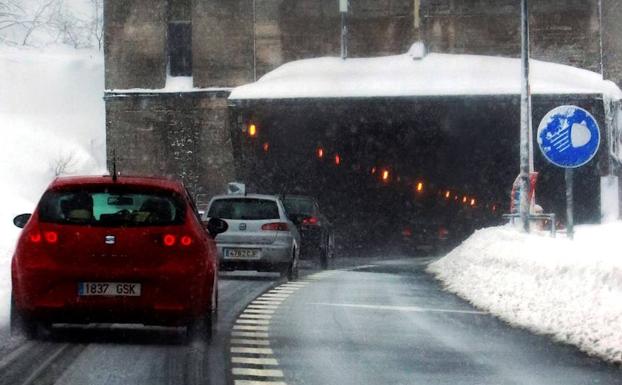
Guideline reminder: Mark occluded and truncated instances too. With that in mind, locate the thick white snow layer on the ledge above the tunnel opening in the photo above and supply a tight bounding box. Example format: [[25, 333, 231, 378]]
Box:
[[230, 46, 622, 100]]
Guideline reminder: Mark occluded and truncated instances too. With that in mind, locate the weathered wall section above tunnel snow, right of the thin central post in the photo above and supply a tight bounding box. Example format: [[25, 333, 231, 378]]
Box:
[[421, 0, 600, 72]]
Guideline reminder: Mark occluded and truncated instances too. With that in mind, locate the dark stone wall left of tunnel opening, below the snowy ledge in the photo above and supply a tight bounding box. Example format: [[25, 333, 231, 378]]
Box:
[[106, 92, 234, 194]]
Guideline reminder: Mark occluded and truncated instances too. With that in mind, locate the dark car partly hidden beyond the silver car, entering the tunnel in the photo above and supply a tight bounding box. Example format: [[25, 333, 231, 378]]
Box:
[[282, 195, 335, 269]]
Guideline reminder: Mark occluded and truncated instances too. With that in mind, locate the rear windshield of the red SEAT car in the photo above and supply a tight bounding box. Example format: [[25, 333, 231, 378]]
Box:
[[39, 186, 185, 227]]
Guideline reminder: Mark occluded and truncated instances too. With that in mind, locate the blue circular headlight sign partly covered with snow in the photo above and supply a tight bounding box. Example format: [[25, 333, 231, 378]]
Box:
[[537, 106, 600, 168]]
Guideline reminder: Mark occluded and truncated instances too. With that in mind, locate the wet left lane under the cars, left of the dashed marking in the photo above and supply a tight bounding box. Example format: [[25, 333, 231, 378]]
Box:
[[0, 273, 279, 385]]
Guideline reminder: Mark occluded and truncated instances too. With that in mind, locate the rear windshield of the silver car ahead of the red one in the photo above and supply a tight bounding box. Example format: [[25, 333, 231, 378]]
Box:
[[207, 199, 279, 220]]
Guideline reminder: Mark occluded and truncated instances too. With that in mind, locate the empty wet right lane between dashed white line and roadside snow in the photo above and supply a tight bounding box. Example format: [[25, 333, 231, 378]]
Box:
[[269, 259, 622, 385]]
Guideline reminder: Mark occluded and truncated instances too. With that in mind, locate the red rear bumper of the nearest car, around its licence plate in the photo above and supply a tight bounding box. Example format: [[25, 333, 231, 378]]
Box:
[[13, 260, 215, 325]]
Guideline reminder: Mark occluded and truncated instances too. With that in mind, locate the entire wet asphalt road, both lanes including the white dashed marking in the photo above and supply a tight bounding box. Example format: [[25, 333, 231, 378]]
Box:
[[0, 258, 622, 385]]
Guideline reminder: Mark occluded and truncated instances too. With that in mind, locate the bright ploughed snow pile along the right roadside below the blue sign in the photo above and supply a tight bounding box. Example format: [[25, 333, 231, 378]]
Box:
[[428, 222, 622, 362]]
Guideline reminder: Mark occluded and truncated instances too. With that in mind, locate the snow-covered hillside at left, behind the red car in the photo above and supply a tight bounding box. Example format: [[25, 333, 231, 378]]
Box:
[[0, 46, 105, 324]]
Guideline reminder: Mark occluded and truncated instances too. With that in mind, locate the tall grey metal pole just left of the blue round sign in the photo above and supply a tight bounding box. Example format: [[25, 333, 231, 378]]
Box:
[[519, 0, 533, 232]]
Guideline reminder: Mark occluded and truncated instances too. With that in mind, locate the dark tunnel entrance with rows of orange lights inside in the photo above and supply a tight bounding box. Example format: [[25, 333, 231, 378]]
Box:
[[231, 95, 604, 254]]
